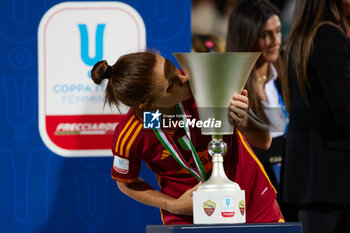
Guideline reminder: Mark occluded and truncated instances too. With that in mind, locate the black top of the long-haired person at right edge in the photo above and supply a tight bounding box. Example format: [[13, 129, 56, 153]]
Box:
[[283, 24, 350, 204]]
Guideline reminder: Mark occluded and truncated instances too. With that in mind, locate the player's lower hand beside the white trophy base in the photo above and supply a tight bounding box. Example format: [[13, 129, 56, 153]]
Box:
[[168, 182, 201, 215]]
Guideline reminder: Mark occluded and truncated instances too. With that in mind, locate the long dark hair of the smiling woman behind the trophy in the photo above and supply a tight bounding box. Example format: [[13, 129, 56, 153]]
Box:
[[226, 0, 283, 123]]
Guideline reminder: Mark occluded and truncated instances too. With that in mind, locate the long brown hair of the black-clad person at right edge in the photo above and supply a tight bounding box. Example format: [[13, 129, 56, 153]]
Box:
[[282, 0, 350, 107]]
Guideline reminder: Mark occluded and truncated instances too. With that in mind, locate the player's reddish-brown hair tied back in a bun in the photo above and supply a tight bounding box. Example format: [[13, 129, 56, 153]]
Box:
[[91, 52, 157, 108]]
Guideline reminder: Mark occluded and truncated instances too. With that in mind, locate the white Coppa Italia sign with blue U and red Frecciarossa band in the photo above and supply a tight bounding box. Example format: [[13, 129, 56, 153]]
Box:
[[38, 1, 146, 156]]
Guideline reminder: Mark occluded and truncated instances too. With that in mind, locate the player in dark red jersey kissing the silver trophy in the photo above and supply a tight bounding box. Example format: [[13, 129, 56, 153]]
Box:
[[91, 52, 283, 224]]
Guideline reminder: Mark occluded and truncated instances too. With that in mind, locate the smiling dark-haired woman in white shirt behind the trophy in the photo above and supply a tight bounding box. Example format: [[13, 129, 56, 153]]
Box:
[[226, 0, 288, 197]]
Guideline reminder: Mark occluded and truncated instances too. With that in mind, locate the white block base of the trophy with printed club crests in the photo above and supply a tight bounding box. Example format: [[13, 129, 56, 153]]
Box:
[[193, 190, 246, 224]]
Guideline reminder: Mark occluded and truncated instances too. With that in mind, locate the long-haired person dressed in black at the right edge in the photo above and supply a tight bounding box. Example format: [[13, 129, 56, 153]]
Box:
[[283, 0, 350, 233]]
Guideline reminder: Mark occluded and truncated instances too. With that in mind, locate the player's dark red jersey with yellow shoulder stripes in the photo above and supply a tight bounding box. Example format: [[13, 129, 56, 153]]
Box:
[[112, 99, 283, 224]]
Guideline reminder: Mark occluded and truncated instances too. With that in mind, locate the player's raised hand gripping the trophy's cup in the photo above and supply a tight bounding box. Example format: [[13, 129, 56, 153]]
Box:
[[228, 89, 249, 128]]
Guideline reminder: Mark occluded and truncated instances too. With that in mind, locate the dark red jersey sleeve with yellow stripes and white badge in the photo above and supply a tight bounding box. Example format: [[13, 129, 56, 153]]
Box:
[[111, 115, 142, 183]]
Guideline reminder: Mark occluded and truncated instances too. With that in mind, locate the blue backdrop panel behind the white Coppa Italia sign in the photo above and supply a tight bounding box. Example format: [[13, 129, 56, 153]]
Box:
[[0, 0, 191, 233]]
